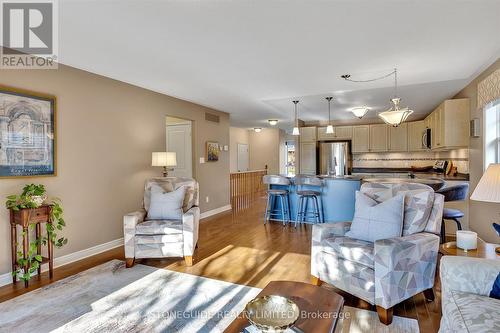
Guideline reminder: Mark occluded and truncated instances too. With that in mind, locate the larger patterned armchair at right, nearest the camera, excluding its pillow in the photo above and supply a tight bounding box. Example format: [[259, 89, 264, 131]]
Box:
[[311, 183, 444, 325]]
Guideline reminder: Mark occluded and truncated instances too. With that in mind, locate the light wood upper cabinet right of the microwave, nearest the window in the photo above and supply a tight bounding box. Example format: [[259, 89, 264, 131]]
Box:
[[425, 98, 470, 150]]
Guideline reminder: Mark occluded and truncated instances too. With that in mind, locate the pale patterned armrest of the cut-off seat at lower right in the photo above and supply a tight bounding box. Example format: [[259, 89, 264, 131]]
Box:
[[440, 256, 500, 296]]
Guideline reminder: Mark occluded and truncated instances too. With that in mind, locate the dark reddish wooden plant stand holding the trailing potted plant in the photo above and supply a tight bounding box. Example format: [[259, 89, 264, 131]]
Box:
[[10, 205, 54, 288]]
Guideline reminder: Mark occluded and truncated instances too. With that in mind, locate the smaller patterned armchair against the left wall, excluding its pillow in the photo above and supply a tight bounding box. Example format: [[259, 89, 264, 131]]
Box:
[[123, 177, 200, 267]]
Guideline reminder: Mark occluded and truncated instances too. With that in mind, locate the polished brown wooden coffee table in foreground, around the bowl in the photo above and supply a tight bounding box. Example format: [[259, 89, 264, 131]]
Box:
[[224, 281, 344, 333]]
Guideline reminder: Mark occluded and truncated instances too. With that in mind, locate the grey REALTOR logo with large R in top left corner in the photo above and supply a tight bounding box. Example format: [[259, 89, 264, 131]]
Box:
[[0, 0, 59, 69]]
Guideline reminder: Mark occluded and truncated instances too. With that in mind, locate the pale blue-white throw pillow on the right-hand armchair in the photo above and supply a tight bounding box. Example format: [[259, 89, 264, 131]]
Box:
[[346, 191, 404, 242]]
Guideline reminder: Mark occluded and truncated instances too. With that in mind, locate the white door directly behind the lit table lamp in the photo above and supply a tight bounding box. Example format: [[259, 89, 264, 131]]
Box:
[[167, 124, 193, 178]]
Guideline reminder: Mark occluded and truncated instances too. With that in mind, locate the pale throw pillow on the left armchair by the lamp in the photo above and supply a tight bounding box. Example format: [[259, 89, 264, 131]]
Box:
[[148, 184, 186, 220]]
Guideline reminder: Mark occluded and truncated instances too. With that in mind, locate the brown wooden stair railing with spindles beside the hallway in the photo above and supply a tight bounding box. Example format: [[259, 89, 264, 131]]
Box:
[[230, 169, 267, 211]]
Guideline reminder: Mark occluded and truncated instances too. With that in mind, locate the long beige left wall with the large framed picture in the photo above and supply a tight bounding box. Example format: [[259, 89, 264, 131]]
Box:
[[0, 65, 229, 274]]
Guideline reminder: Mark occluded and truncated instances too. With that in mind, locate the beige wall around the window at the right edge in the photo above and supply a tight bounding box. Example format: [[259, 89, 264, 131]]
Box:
[[454, 59, 500, 243]]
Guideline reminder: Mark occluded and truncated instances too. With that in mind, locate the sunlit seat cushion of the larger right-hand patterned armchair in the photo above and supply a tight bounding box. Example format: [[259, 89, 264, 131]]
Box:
[[323, 236, 374, 269]]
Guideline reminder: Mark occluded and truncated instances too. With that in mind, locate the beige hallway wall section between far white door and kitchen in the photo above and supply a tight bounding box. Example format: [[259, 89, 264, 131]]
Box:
[[249, 128, 280, 174]]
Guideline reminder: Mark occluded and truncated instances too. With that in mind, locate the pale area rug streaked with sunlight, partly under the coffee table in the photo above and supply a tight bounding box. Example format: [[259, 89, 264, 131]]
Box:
[[0, 260, 418, 333]]
